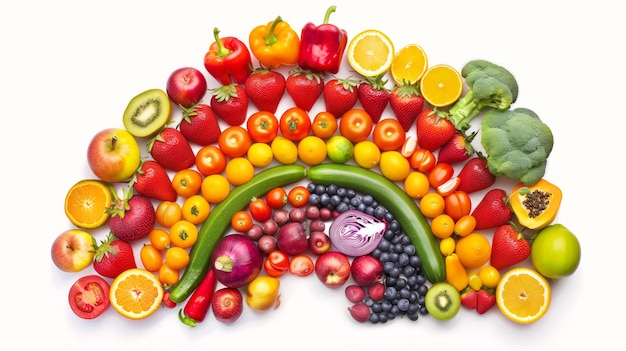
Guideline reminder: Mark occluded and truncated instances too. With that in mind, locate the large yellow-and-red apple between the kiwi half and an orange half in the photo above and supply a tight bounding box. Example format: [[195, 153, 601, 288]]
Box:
[[87, 128, 141, 183]]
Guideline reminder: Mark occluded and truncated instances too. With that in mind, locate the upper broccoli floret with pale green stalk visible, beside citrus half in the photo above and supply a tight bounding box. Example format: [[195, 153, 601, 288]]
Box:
[[448, 60, 518, 131]]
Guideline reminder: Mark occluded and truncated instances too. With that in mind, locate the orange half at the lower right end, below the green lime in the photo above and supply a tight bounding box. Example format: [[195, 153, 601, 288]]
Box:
[[496, 267, 551, 324]]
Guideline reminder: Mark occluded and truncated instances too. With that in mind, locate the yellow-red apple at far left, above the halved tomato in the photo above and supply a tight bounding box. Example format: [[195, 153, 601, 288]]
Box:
[[50, 229, 95, 272]]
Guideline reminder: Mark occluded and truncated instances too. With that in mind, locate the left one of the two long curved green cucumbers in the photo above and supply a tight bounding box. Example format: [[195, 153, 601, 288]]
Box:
[[170, 164, 307, 303]]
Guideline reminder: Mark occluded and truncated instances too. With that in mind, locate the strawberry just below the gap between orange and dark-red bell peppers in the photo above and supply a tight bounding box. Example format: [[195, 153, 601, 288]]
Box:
[[285, 68, 324, 112]]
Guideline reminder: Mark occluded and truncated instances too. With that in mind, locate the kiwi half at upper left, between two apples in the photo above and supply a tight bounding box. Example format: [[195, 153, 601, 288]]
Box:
[[123, 89, 172, 138]]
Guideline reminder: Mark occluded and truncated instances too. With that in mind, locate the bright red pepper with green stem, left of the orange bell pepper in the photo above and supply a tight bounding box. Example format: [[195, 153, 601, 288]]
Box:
[[204, 28, 252, 85]]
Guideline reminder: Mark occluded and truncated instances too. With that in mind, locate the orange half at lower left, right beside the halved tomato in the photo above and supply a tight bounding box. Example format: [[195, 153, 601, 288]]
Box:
[[109, 268, 163, 319]]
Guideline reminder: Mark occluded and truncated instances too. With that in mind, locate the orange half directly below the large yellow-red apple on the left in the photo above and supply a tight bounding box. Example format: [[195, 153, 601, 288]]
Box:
[[65, 179, 112, 229]]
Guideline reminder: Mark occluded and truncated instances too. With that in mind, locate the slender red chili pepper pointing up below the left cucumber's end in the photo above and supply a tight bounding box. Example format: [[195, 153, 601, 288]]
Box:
[[178, 269, 217, 327]]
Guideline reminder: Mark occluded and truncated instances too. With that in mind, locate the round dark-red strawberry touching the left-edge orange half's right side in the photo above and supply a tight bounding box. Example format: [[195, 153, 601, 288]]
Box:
[[107, 187, 156, 242]]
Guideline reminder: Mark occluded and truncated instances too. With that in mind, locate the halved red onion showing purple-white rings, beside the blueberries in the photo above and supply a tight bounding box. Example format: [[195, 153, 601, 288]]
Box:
[[329, 210, 387, 257]]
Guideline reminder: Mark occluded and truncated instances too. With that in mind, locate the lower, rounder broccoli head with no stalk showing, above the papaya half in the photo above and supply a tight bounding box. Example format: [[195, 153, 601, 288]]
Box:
[[481, 108, 554, 185]]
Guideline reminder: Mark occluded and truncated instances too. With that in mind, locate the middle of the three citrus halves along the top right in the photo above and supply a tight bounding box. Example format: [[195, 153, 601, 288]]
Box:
[[390, 44, 428, 85]]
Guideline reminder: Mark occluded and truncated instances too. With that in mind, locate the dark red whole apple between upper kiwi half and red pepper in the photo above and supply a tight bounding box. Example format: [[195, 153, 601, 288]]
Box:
[[166, 67, 207, 107]]
